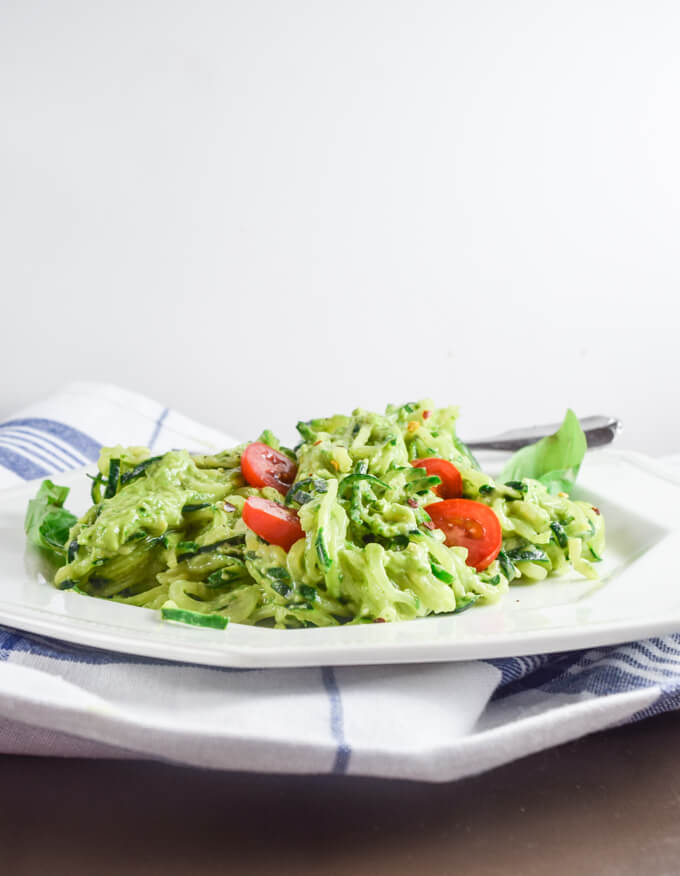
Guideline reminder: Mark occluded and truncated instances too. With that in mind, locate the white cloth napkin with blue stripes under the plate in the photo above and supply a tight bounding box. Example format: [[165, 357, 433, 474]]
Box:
[[0, 383, 680, 781]]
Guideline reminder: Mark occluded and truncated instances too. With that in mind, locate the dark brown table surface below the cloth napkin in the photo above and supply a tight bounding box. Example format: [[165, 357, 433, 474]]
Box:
[[0, 713, 680, 876]]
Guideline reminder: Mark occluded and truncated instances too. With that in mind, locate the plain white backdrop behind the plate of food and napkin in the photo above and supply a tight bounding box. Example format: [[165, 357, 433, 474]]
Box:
[[0, 0, 680, 453]]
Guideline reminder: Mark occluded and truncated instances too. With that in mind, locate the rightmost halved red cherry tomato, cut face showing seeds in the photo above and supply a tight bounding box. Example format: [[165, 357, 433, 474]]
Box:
[[425, 499, 503, 572]]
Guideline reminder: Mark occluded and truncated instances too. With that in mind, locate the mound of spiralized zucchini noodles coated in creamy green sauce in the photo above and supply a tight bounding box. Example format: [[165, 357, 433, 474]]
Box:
[[55, 400, 604, 627]]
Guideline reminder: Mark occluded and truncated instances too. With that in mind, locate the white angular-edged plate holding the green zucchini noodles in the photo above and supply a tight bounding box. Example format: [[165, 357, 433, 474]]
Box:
[[0, 450, 680, 667]]
